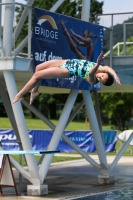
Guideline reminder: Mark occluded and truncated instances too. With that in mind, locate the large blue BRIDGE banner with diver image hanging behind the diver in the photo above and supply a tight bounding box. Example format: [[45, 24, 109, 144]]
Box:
[[32, 8, 103, 90]]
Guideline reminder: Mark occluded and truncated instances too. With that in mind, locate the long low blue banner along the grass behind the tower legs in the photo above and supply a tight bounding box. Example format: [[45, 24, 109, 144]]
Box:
[[0, 129, 117, 152]]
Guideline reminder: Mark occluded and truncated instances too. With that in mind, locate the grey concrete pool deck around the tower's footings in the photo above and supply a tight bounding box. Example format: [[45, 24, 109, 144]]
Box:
[[0, 154, 133, 200]]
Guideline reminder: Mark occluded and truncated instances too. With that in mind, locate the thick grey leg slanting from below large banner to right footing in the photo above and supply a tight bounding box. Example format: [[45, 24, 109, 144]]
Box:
[[82, 90, 109, 175]]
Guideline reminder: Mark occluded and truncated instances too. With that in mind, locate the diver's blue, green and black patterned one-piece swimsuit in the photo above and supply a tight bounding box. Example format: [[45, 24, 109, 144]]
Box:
[[60, 59, 96, 78]]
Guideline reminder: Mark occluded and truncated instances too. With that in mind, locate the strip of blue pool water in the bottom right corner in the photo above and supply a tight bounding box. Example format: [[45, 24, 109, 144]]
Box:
[[70, 187, 133, 200]]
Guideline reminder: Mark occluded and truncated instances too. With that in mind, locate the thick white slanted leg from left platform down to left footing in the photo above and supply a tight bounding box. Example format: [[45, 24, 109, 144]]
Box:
[[4, 78, 40, 184]]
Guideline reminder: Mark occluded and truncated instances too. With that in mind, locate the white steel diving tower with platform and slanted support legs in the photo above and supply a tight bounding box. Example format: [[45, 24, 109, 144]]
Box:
[[0, 0, 133, 195]]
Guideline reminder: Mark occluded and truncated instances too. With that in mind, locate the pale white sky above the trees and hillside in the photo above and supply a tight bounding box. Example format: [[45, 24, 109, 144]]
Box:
[[2, 0, 133, 27]]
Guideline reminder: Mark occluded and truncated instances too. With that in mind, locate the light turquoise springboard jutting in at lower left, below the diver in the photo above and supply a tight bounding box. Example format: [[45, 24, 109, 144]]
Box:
[[0, 150, 60, 154]]
